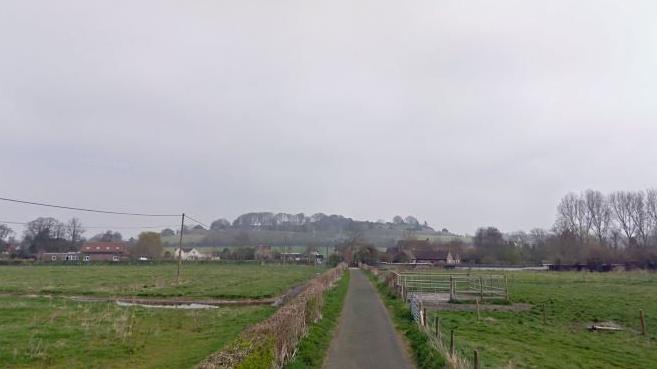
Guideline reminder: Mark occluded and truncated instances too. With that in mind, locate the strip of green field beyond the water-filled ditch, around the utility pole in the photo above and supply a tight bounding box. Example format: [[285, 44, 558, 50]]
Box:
[[0, 263, 323, 299]]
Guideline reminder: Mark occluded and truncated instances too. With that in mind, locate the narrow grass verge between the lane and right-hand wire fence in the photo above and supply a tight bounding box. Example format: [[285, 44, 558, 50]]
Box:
[[366, 272, 445, 369]]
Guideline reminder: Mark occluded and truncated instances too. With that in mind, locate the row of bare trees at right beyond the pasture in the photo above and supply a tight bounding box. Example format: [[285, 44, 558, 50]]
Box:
[[463, 189, 657, 268]]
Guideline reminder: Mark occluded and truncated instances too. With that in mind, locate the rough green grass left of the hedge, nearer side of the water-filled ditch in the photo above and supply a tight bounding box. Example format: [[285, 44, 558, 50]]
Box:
[[0, 296, 273, 369]]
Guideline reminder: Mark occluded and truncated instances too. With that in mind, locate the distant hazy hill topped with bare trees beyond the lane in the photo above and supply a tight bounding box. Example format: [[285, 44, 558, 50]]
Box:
[[162, 212, 467, 247]]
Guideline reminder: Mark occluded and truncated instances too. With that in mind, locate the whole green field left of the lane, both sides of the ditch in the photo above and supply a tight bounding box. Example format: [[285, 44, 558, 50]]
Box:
[[0, 264, 323, 369]]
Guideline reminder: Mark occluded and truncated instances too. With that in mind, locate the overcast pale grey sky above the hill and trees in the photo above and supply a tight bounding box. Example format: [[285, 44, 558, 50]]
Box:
[[0, 0, 657, 233]]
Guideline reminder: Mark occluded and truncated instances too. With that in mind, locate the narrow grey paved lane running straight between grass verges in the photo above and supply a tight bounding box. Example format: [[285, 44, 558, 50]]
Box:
[[324, 269, 414, 369]]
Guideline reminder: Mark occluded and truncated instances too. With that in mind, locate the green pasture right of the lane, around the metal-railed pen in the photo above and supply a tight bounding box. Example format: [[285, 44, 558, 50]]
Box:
[[430, 273, 657, 369]]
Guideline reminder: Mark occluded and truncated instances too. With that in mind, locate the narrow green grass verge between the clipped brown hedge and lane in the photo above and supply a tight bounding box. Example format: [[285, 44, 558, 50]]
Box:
[[285, 270, 349, 369]]
